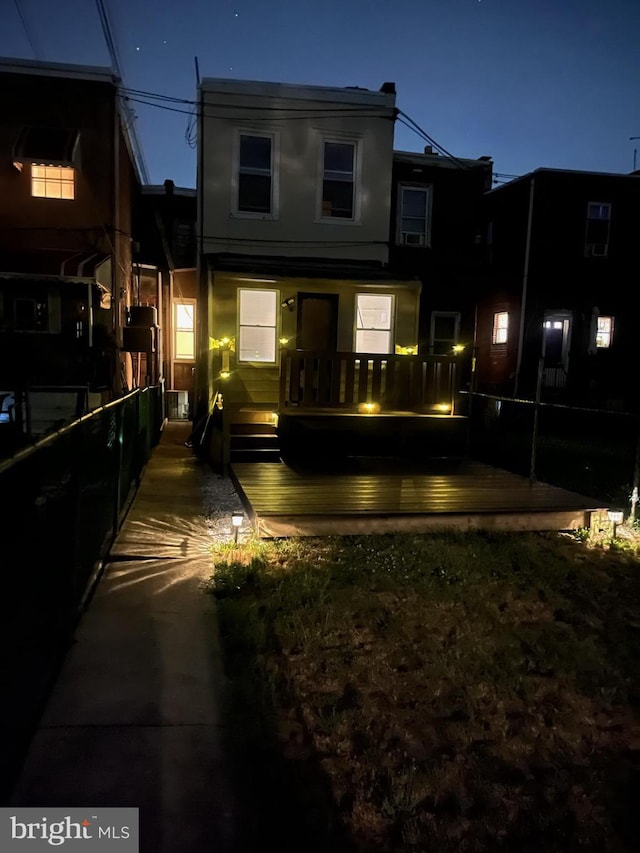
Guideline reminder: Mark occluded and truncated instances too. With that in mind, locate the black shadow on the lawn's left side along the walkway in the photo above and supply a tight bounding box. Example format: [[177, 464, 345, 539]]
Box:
[[213, 576, 356, 853]]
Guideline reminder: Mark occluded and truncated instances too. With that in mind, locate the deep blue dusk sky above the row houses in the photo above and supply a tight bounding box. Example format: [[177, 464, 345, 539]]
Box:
[[5, 0, 640, 186]]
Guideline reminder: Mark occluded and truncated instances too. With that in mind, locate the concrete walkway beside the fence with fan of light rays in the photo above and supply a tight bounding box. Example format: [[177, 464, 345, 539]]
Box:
[[11, 422, 243, 853]]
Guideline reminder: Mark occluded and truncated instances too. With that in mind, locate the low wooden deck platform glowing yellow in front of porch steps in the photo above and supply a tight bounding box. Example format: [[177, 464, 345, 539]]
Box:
[[231, 460, 605, 538]]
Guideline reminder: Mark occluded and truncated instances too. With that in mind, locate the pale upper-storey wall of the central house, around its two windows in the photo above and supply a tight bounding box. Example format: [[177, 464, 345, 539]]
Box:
[[198, 80, 395, 262]]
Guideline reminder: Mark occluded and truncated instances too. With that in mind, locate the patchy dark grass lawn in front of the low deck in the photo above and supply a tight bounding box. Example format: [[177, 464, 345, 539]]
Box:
[[212, 533, 640, 853]]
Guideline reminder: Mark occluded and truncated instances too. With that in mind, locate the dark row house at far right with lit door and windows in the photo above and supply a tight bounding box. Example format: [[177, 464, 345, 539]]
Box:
[[476, 169, 640, 411]]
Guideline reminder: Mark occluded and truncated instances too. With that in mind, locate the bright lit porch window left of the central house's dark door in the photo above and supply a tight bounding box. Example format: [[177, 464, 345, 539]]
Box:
[[237, 289, 278, 364]]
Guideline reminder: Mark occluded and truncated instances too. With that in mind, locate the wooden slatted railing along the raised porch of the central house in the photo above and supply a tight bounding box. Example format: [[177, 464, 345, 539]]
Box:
[[280, 350, 458, 412]]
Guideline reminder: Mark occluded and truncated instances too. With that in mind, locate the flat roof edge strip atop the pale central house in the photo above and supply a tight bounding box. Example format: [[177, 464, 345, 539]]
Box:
[[198, 77, 396, 107]]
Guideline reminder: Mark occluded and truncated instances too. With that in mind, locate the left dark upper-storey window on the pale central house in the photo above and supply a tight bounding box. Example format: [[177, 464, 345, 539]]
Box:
[[236, 133, 274, 214]]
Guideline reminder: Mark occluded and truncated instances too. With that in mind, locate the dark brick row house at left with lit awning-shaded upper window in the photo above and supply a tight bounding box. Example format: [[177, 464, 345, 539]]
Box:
[[0, 59, 145, 435]]
